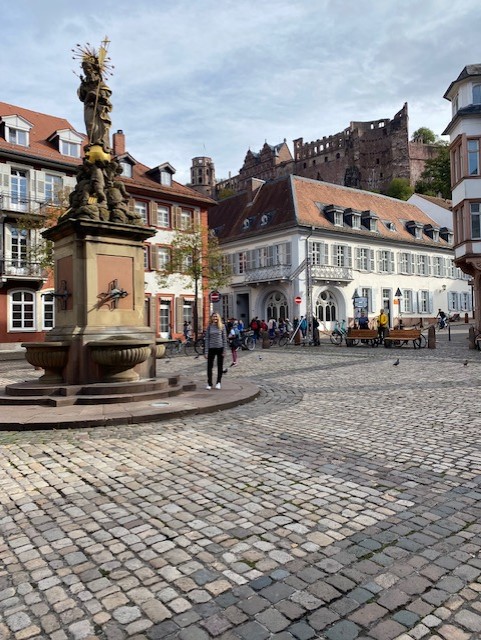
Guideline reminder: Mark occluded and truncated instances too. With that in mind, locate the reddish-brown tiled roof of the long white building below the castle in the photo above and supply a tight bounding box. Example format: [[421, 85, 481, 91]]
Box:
[[209, 176, 447, 246]]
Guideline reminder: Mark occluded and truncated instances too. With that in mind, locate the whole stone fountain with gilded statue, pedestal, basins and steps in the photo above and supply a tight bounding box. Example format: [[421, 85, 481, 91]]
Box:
[[1, 40, 192, 406]]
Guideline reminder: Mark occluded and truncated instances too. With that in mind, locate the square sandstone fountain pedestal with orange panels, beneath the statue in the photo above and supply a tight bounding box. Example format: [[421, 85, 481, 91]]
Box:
[[40, 218, 156, 385]]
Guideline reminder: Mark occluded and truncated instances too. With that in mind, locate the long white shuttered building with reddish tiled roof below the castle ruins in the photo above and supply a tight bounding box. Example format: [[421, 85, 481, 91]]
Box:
[[209, 176, 472, 330]]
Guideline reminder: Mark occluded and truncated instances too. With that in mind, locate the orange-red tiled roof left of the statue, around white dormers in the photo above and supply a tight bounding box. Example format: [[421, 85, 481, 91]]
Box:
[[0, 102, 86, 166]]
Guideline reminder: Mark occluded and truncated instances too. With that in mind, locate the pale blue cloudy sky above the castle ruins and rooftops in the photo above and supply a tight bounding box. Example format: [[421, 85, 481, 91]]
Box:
[[0, 0, 481, 182]]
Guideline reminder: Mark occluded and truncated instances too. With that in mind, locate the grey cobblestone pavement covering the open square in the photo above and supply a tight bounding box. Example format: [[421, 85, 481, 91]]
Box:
[[0, 327, 481, 640]]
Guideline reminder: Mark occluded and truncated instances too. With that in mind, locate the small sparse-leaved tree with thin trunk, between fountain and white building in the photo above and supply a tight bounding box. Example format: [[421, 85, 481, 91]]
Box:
[[157, 226, 231, 338]]
